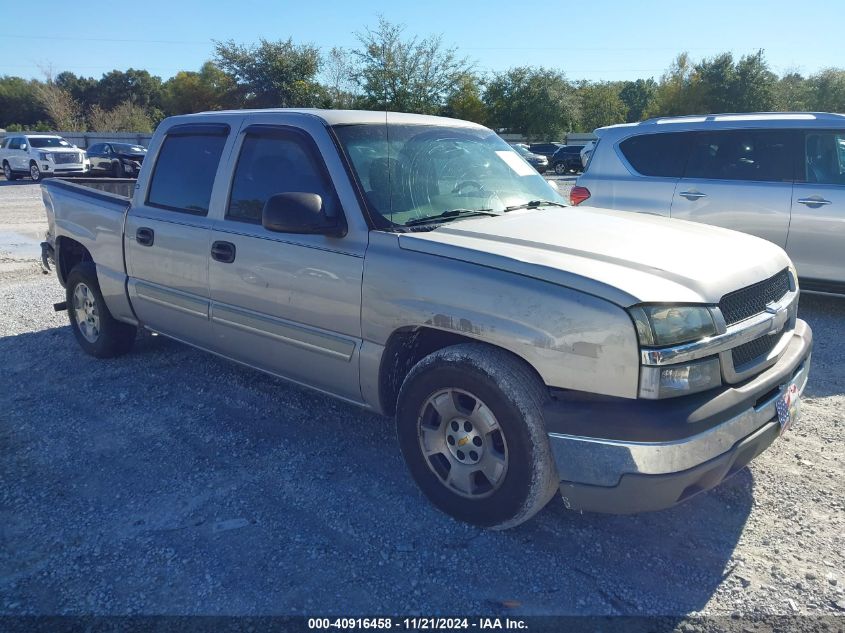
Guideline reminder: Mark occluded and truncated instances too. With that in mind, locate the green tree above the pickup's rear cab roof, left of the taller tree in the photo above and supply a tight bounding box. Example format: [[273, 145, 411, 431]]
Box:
[[162, 62, 237, 116]]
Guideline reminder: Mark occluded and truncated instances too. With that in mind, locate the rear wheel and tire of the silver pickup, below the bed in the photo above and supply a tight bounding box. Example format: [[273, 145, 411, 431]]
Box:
[[65, 262, 137, 358]]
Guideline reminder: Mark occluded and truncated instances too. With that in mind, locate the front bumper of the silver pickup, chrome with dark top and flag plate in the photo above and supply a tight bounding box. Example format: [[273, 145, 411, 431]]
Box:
[[546, 320, 813, 514]]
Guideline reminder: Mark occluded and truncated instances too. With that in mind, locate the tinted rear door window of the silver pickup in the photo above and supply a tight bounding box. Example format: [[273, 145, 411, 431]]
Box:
[[147, 133, 226, 215]]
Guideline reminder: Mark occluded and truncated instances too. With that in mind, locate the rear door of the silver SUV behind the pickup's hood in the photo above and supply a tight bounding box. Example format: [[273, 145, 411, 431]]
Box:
[[671, 129, 796, 248]]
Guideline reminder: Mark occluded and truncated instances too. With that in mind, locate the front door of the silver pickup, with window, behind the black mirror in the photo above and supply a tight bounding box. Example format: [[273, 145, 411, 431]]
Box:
[[209, 125, 366, 401]]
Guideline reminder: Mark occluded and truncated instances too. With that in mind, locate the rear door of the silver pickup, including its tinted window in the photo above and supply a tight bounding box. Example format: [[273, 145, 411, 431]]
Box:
[[124, 124, 234, 347]]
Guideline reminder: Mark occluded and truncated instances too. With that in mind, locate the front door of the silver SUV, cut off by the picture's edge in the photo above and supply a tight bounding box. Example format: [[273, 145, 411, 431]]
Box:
[[786, 129, 845, 292]]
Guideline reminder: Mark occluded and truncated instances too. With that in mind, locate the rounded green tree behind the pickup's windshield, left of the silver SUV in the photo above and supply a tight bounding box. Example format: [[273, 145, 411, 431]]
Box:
[[484, 66, 579, 140]]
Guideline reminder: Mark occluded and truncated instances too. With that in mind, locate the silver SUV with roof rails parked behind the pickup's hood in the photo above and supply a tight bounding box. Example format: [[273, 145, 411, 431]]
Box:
[[571, 112, 845, 294]]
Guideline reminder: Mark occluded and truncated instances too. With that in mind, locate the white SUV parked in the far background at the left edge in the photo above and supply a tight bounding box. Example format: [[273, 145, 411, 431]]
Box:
[[0, 134, 88, 182]]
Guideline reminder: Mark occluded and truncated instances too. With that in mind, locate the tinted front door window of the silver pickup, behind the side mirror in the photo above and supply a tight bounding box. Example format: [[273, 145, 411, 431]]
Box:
[[231, 131, 338, 223]]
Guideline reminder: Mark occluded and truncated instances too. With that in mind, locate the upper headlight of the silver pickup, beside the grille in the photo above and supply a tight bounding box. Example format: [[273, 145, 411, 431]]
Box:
[[629, 306, 716, 347]]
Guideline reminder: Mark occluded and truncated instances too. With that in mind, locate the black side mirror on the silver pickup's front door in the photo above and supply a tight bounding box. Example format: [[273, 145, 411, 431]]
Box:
[[261, 191, 346, 237]]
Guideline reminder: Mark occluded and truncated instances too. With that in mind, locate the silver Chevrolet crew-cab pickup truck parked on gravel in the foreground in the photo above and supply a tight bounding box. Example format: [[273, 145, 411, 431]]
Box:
[[42, 110, 812, 528]]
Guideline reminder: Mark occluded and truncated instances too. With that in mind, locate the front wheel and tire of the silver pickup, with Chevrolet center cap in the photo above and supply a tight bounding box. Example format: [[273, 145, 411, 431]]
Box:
[[396, 343, 560, 530]]
